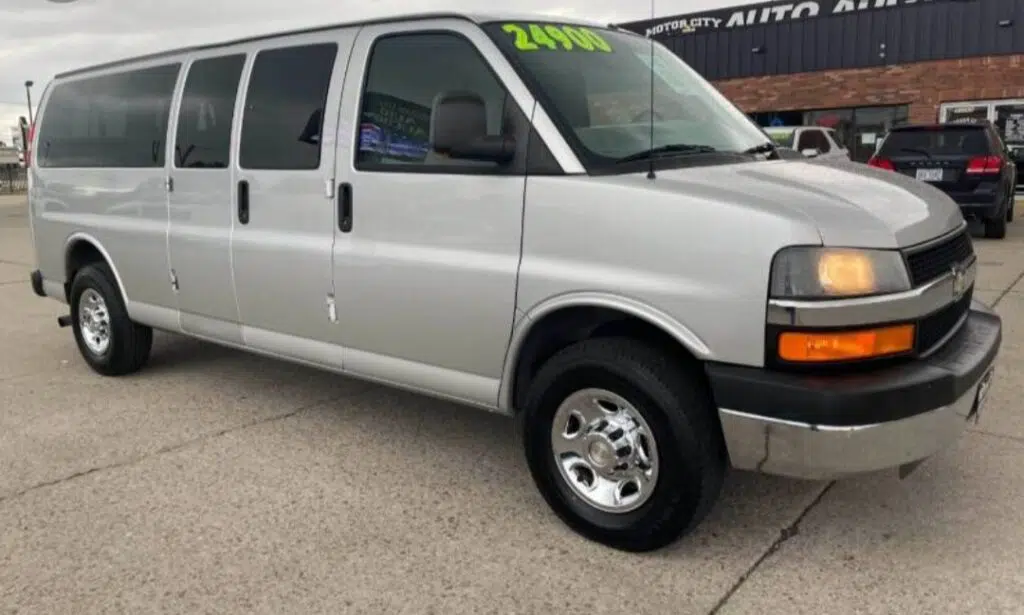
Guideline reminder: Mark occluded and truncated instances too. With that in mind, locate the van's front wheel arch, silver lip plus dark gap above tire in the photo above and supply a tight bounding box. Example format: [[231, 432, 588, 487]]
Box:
[[498, 293, 712, 414]]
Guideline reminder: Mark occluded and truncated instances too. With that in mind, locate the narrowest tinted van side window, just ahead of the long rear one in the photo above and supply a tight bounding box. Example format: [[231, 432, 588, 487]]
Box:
[[174, 53, 246, 169]]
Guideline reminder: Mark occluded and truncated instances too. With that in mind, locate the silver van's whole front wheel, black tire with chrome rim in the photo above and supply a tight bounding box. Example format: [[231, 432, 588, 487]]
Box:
[[520, 338, 727, 552]]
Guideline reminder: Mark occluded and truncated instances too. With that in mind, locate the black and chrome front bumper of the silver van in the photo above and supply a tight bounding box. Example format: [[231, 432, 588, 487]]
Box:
[[708, 302, 1002, 480]]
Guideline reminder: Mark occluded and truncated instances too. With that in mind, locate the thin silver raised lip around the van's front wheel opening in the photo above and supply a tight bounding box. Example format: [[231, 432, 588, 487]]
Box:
[[498, 292, 712, 414]]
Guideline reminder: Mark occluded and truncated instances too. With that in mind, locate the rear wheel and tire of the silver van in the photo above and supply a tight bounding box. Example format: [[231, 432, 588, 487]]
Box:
[[70, 263, 153, 376]]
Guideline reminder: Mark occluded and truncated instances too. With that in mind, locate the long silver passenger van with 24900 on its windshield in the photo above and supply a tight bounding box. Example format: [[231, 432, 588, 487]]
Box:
[[22, 14, 1001, 551]]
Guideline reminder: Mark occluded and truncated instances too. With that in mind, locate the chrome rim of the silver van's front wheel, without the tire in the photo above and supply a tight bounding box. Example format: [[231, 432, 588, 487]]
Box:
[[551, 389, 657, 514]]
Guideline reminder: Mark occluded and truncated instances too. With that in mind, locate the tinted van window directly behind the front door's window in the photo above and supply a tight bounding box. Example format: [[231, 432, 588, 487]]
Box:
[[239, 43, 338, 170]]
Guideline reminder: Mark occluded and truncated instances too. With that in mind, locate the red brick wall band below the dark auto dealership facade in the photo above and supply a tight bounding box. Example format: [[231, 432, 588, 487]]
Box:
[[715, 54, 1024, 123]]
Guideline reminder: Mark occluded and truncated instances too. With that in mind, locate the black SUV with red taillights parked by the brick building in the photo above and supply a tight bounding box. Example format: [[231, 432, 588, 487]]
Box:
[[867, 122, 1017, 239]]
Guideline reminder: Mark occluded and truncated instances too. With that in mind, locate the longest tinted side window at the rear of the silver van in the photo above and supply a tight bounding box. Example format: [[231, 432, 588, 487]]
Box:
[[36, 63, 181, 168]]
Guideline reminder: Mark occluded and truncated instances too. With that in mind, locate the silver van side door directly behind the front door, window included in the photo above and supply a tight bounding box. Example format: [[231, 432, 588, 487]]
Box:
[[231, 30, 352, 367]]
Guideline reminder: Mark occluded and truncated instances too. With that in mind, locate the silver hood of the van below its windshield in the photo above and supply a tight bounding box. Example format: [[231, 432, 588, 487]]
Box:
[[656, 160, 964, 249]]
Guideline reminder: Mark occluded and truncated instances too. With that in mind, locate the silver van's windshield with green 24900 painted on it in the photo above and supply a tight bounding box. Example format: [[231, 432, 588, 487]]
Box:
[[483, 21, 768, 172]]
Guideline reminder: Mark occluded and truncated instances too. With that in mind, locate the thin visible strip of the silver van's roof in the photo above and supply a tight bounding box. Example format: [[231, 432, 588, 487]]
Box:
[[54, 11, 618, 80]]
